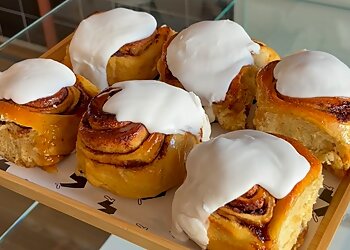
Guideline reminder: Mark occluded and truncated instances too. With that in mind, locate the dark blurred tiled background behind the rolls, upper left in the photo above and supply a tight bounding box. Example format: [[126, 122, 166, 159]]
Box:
[[0, 0, 233, 70]]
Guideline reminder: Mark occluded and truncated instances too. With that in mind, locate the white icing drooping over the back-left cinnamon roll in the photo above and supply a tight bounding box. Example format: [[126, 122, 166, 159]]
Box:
[[69, 8, 157, 90]]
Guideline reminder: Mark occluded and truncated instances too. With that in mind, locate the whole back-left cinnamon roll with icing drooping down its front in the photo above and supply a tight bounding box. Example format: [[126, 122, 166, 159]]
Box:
[[64, 8, 173, 90]]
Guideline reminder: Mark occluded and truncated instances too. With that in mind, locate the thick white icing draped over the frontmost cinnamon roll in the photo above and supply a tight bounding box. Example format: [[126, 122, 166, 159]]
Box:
[[172, 130, 310, 248]]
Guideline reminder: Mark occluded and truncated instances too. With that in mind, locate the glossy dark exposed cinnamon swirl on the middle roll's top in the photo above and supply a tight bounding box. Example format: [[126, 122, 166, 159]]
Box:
[[79, 89, 172, 168]]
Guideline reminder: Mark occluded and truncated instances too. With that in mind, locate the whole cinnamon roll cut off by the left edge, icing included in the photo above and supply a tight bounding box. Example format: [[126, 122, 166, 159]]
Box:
[[0, 59, 97, 168]]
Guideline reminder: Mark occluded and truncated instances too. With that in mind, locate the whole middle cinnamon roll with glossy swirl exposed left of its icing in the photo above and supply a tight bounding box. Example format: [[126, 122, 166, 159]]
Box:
[[76, 80, 210, 198]]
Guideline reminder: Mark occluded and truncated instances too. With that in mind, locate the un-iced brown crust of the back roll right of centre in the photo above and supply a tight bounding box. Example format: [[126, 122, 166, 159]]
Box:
[[157, 34, 279, 130]]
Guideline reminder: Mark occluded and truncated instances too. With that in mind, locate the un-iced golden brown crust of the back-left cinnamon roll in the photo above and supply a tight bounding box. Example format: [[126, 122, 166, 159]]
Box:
[[64, 26, 174, 88]]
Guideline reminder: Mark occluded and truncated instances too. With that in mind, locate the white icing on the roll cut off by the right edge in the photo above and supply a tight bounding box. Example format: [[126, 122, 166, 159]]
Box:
[[273, 51, 350, 98]]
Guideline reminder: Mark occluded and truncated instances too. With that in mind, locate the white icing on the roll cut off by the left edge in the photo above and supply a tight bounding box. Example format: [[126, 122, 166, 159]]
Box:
[[0, 58, 76, 104]]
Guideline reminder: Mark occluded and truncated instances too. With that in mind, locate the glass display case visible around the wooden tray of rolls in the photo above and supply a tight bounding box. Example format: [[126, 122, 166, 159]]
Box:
[[0, 0, 350, 250]]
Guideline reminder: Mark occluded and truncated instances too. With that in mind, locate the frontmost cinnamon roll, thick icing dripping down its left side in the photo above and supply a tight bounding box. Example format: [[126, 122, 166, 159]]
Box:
[[172, 130, 323, 250]]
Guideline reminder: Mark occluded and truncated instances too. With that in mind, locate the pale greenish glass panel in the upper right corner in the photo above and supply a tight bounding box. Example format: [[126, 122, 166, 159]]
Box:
[[234, 0, 350, 66]]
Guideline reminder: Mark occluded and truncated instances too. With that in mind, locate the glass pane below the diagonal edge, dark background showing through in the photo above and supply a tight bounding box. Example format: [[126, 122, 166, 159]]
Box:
[[0, 0, 236, 70]]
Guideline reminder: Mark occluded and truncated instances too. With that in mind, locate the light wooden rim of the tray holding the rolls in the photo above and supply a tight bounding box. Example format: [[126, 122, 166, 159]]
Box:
[[0, 35, 350, 249]]
